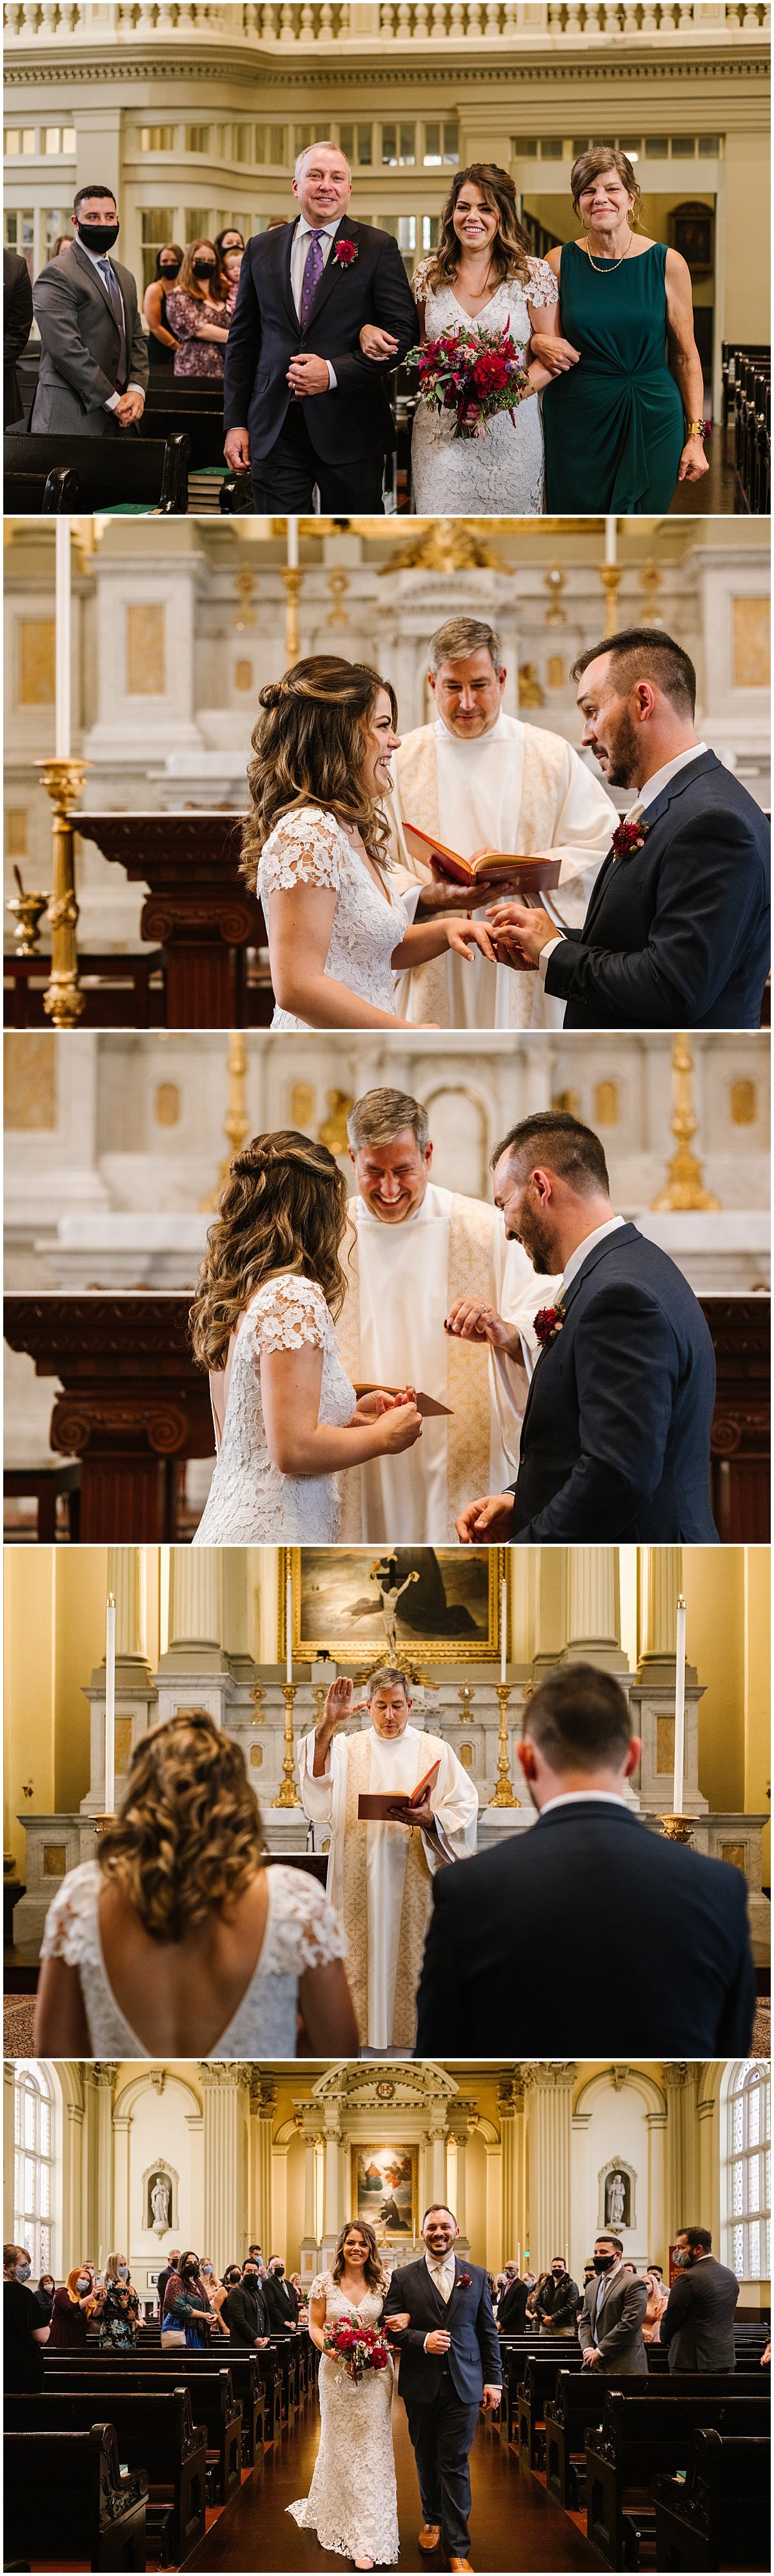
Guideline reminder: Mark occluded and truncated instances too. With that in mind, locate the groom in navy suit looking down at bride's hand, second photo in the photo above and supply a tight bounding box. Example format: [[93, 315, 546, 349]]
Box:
[[490, 626, 771, 1028]]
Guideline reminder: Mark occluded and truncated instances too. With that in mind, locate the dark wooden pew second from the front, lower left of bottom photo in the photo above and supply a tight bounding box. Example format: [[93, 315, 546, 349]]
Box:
[[5, 2372, 206, 2566]]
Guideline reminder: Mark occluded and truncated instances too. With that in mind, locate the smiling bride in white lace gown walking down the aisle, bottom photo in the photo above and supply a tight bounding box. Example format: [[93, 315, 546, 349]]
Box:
[[286, 2221, 408, 2568]]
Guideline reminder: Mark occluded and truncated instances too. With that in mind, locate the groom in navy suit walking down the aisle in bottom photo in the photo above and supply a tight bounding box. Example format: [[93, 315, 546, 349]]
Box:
[[384, 2203, 503, 2568]]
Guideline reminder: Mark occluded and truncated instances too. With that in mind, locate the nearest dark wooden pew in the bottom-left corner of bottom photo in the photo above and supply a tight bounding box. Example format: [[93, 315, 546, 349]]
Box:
[[3, 2424, 147, 2571]]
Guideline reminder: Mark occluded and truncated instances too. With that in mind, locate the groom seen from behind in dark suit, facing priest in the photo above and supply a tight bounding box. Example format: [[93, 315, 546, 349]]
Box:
[[418, 1664, 756, 2050]]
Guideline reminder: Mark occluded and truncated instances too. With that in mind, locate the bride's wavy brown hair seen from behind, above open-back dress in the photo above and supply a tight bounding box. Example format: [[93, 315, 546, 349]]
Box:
[[95, 1708, 266, 1942]]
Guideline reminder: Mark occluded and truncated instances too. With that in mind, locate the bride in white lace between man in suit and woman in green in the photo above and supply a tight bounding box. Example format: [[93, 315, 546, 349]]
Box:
[[361, 162, 557, 518]]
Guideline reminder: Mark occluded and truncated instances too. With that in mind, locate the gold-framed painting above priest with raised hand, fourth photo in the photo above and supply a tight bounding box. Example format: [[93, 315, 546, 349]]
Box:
[[279, 1548, 506, 1672]]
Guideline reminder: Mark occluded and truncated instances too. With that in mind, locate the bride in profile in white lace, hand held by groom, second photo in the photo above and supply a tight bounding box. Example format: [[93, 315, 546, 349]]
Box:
[[243, 654, 493, 1030]]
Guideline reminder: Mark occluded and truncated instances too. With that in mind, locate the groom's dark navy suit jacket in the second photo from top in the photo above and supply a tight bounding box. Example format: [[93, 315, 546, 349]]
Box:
[[544, 752, 771, 1028]]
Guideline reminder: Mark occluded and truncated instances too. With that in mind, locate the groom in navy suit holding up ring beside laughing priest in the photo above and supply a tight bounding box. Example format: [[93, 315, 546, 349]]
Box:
[[446, 1110, 717, 1548]]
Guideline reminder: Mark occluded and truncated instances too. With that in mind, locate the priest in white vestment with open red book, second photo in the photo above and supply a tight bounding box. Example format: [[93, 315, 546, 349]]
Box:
[[392, 618, 619, 1028]]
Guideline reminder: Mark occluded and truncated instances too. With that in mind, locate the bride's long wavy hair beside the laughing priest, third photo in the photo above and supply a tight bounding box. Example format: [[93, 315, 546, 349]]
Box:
[[188, 1128, 348, 1368]]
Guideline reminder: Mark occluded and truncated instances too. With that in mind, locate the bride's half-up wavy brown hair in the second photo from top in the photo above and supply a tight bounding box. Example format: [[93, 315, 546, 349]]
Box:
[[243, 652, 397, 891]]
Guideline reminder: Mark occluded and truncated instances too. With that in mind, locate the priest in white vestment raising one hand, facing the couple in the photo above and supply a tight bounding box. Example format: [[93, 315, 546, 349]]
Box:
[[299, 1667, 477, 2050]]
